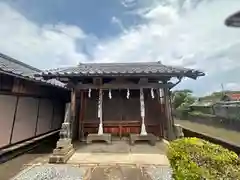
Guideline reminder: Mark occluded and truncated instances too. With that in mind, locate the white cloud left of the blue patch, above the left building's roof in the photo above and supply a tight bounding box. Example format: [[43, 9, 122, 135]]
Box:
[[0, 3, 86, 69]]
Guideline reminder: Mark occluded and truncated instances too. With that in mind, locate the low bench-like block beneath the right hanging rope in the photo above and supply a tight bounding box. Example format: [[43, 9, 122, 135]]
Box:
[[129, 133, 157, 146]]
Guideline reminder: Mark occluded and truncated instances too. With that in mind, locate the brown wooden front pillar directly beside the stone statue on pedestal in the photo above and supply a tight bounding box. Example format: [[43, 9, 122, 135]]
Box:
[[70, 88, 76, 139]]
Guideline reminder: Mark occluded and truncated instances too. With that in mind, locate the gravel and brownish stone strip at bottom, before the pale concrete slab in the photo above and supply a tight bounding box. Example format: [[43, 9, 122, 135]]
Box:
[[12, 164, 172, 180]]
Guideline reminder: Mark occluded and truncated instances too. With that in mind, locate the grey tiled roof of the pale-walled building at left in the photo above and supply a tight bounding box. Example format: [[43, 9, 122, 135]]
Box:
[[0, 53, 65, 87]]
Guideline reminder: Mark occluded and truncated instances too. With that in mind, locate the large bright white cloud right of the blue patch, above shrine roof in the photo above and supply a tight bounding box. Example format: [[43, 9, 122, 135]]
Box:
[[93, 0, 240, 74]]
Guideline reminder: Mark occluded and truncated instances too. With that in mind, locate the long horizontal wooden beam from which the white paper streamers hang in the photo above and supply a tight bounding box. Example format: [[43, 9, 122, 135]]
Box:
[[75, 83, 174, 90]]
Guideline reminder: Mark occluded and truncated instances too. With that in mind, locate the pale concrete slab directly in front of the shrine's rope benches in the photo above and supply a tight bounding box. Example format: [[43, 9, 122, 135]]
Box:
[[68, 140, 169, 166]]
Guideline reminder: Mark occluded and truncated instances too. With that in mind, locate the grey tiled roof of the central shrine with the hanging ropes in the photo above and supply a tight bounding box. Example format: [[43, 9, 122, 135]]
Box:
[[41, 62, 205, 79]]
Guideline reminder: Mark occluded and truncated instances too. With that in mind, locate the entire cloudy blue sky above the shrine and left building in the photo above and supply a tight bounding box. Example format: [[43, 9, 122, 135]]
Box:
[[0, 0, 240, 95]]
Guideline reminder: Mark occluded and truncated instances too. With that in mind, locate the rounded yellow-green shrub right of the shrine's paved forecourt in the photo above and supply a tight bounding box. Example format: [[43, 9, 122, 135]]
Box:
[[167, 138, 240, 180]]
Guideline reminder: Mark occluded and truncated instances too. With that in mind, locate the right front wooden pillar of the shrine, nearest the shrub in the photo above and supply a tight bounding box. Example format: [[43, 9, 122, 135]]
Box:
[[164, 88, 174, 140]]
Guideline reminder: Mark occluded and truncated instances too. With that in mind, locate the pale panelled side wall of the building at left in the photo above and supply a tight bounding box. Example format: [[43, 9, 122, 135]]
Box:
[[0, 95, 65, 148]]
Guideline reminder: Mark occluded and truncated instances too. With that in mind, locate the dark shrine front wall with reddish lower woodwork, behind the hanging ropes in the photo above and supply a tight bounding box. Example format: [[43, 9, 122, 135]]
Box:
[[80, 90, 165, 136]]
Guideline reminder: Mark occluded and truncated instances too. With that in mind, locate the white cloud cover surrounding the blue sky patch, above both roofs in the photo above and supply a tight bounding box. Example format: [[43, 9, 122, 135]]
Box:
[[0, 0, 240, 93]]
